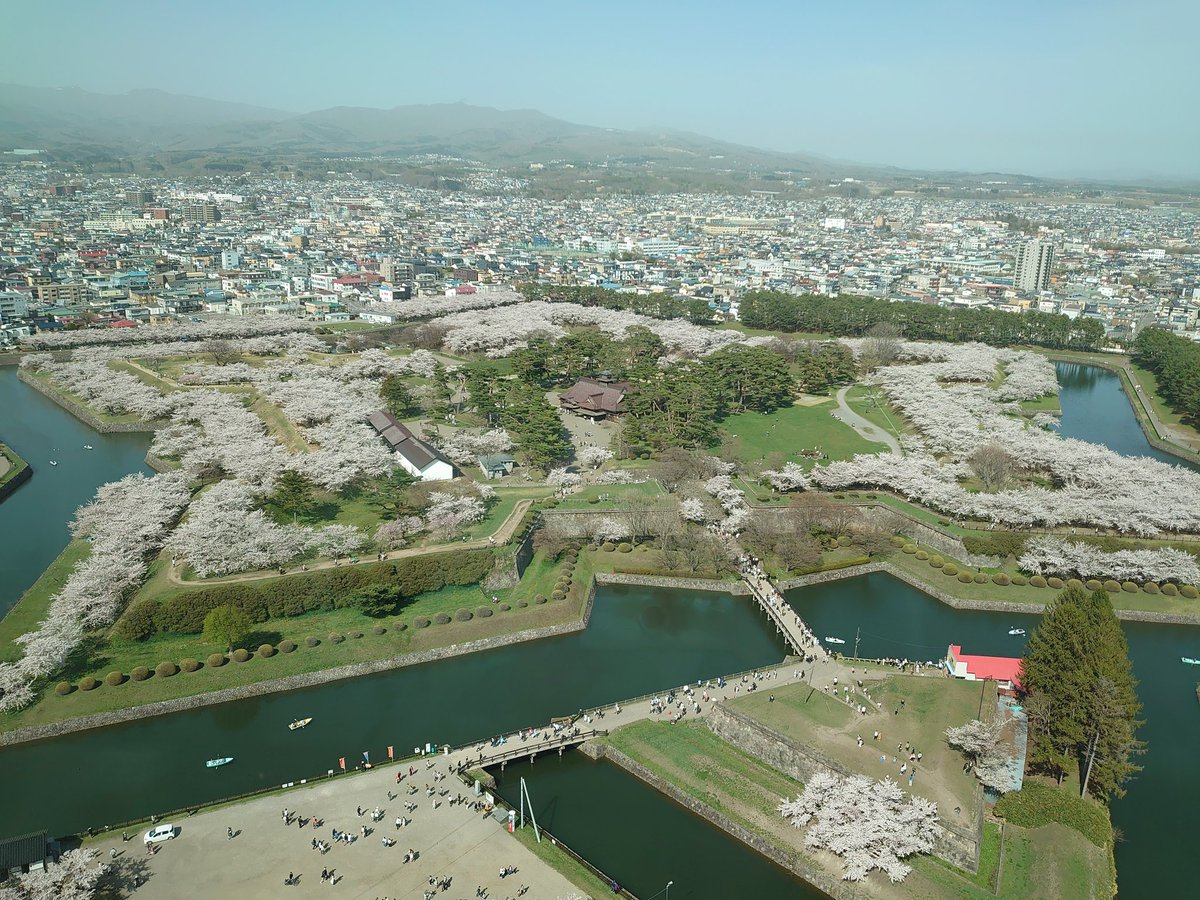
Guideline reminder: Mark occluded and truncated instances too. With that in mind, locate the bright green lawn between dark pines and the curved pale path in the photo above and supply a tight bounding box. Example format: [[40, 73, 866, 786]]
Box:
[[721, 398, 883, 468]]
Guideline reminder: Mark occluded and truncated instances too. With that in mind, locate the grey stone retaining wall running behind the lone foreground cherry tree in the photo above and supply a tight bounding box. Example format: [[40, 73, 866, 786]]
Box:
[[706, 703, 983, 872]]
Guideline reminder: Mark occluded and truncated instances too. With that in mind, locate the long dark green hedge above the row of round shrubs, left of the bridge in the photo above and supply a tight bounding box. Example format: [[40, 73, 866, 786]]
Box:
[[142, 550, 492, 640]]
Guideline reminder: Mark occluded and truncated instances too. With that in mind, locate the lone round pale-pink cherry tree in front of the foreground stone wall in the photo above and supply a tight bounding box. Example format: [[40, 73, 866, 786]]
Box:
[[778, 772, 940, 882]]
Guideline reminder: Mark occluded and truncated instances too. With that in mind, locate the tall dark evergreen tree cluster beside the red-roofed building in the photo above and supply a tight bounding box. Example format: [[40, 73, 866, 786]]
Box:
[[1021, 588, 1144, 799]]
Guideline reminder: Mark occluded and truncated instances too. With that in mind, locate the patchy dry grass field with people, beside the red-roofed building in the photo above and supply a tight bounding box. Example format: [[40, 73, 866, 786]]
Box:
[[727, 673, 996, 827]]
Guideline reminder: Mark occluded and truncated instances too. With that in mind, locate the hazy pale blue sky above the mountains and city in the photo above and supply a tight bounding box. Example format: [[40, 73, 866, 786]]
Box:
[[9, 0, 1200, 178]]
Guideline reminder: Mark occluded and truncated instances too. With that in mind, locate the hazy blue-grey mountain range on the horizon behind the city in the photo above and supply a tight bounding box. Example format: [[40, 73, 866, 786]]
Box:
[[0, 84, 856, 174]]
